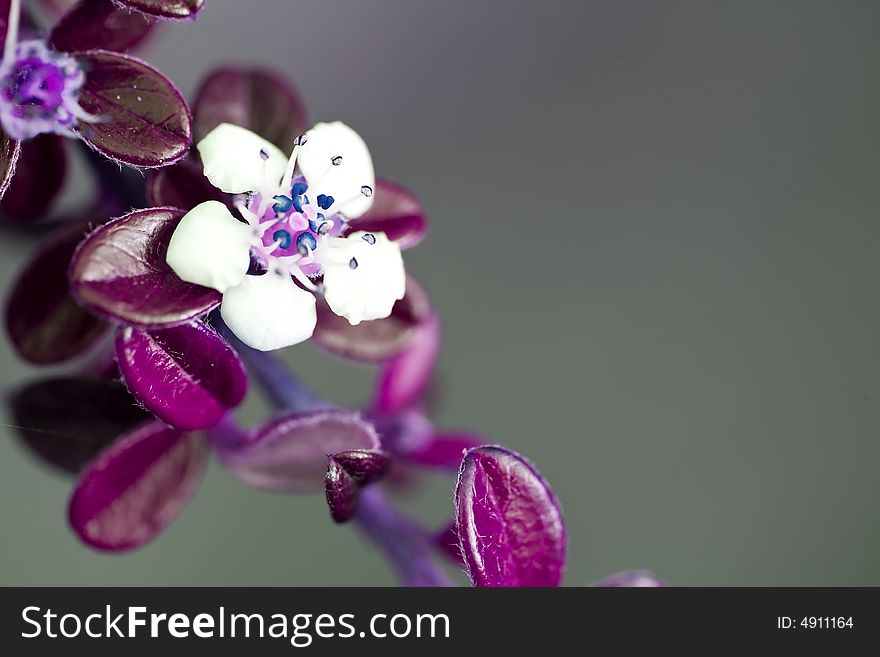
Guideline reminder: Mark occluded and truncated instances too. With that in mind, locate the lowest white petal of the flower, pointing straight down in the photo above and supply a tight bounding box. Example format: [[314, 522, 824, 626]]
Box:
[[220, 270, 317, 351]]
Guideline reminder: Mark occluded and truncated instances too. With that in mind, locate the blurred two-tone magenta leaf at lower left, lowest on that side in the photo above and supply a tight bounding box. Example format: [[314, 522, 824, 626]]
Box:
[[68, 422, 208, 552]]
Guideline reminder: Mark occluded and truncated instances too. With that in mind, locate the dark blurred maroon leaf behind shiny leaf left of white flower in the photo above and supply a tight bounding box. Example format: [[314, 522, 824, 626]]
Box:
[[6, 222, 107, 365]]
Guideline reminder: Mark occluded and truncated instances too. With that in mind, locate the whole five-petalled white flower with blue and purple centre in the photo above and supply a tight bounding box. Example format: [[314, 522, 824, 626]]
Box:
[[167, 122, 406, 351]]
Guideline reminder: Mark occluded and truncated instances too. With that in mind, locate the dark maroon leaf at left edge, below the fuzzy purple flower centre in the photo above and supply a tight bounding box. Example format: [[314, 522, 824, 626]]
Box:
[[0, 135, 67, 221]]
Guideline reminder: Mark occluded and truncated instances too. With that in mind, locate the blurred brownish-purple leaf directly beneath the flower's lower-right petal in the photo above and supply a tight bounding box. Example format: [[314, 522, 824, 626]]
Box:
[[312, 276, 434, 363]]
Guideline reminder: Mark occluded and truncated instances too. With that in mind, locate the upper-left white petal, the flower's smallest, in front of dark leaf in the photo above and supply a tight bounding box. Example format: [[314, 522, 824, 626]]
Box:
[[197, 123, 287, 194]]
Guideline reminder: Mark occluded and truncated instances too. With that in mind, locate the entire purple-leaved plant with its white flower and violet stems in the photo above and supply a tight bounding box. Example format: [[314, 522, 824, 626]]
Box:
[[0, 0, 660, 586]]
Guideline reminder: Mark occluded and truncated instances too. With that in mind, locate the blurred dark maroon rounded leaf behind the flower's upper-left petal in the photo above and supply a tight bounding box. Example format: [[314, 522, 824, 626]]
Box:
[[193, 68, 309, 152]]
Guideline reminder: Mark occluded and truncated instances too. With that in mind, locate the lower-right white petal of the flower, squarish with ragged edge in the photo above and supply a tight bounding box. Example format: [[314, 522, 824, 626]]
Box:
[[315, 231, 406, 324]]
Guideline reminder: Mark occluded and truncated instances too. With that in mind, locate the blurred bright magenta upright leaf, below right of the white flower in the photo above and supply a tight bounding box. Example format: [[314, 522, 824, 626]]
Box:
[[374, 315, 440, 414]]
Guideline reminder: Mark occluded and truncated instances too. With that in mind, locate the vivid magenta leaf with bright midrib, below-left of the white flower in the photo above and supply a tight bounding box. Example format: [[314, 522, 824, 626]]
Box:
[[116, 321, 247, 430]]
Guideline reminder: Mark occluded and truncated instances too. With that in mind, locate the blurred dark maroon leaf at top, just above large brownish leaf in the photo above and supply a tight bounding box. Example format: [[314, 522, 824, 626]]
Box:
[[49, 0, 156, 52]]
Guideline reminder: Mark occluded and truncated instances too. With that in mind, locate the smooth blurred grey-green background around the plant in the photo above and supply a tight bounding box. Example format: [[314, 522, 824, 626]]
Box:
[[0, 0, 880, 585]]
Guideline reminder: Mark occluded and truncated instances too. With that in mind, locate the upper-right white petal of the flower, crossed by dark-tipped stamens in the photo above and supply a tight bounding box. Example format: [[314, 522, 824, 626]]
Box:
[[297, 121, 376, 219]]
